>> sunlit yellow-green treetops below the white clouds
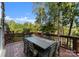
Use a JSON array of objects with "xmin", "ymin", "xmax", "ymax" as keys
[{"xmin": 8, "ymin": 21, "xmax": 40, "ymax": 33}]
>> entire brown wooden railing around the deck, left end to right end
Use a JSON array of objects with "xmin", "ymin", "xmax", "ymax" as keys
[{"xmin": 5, "ymin": 32, "xmax": 79, "ymax": 53}]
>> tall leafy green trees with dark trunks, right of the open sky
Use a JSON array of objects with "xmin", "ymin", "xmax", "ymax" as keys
[{"xmin": 34, "ymin": 2, "xmax": 79, "ymax": 35}]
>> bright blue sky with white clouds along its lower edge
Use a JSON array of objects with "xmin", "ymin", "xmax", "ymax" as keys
[{"xmin": 0, "ymin": 2, "xmax": 35, "ymax": 23}]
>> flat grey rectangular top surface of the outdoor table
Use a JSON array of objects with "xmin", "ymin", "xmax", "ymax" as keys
[{"xmin": 25, "ymin": 36, "xmax": 55, "ymax": 49}]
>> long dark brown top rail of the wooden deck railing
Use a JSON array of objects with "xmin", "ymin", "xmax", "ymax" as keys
[{"xmin": 4, "ymin": 32, "xmax": 79, "ymax": 39}]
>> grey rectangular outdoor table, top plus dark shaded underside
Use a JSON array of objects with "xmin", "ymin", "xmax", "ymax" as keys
[{"xmin": 25, "ymin": 36, "xmax": 56, "ymax": 56}]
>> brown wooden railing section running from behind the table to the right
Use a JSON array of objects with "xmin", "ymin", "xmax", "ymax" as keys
[{"xmin": 34, "ymin": 33, "xmax": 79, "ymax": 53}]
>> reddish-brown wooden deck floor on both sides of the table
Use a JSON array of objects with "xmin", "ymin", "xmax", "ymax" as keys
[{"xmin": 5, "ymin": 41, "xmax": 78, "ymax": 57}]
